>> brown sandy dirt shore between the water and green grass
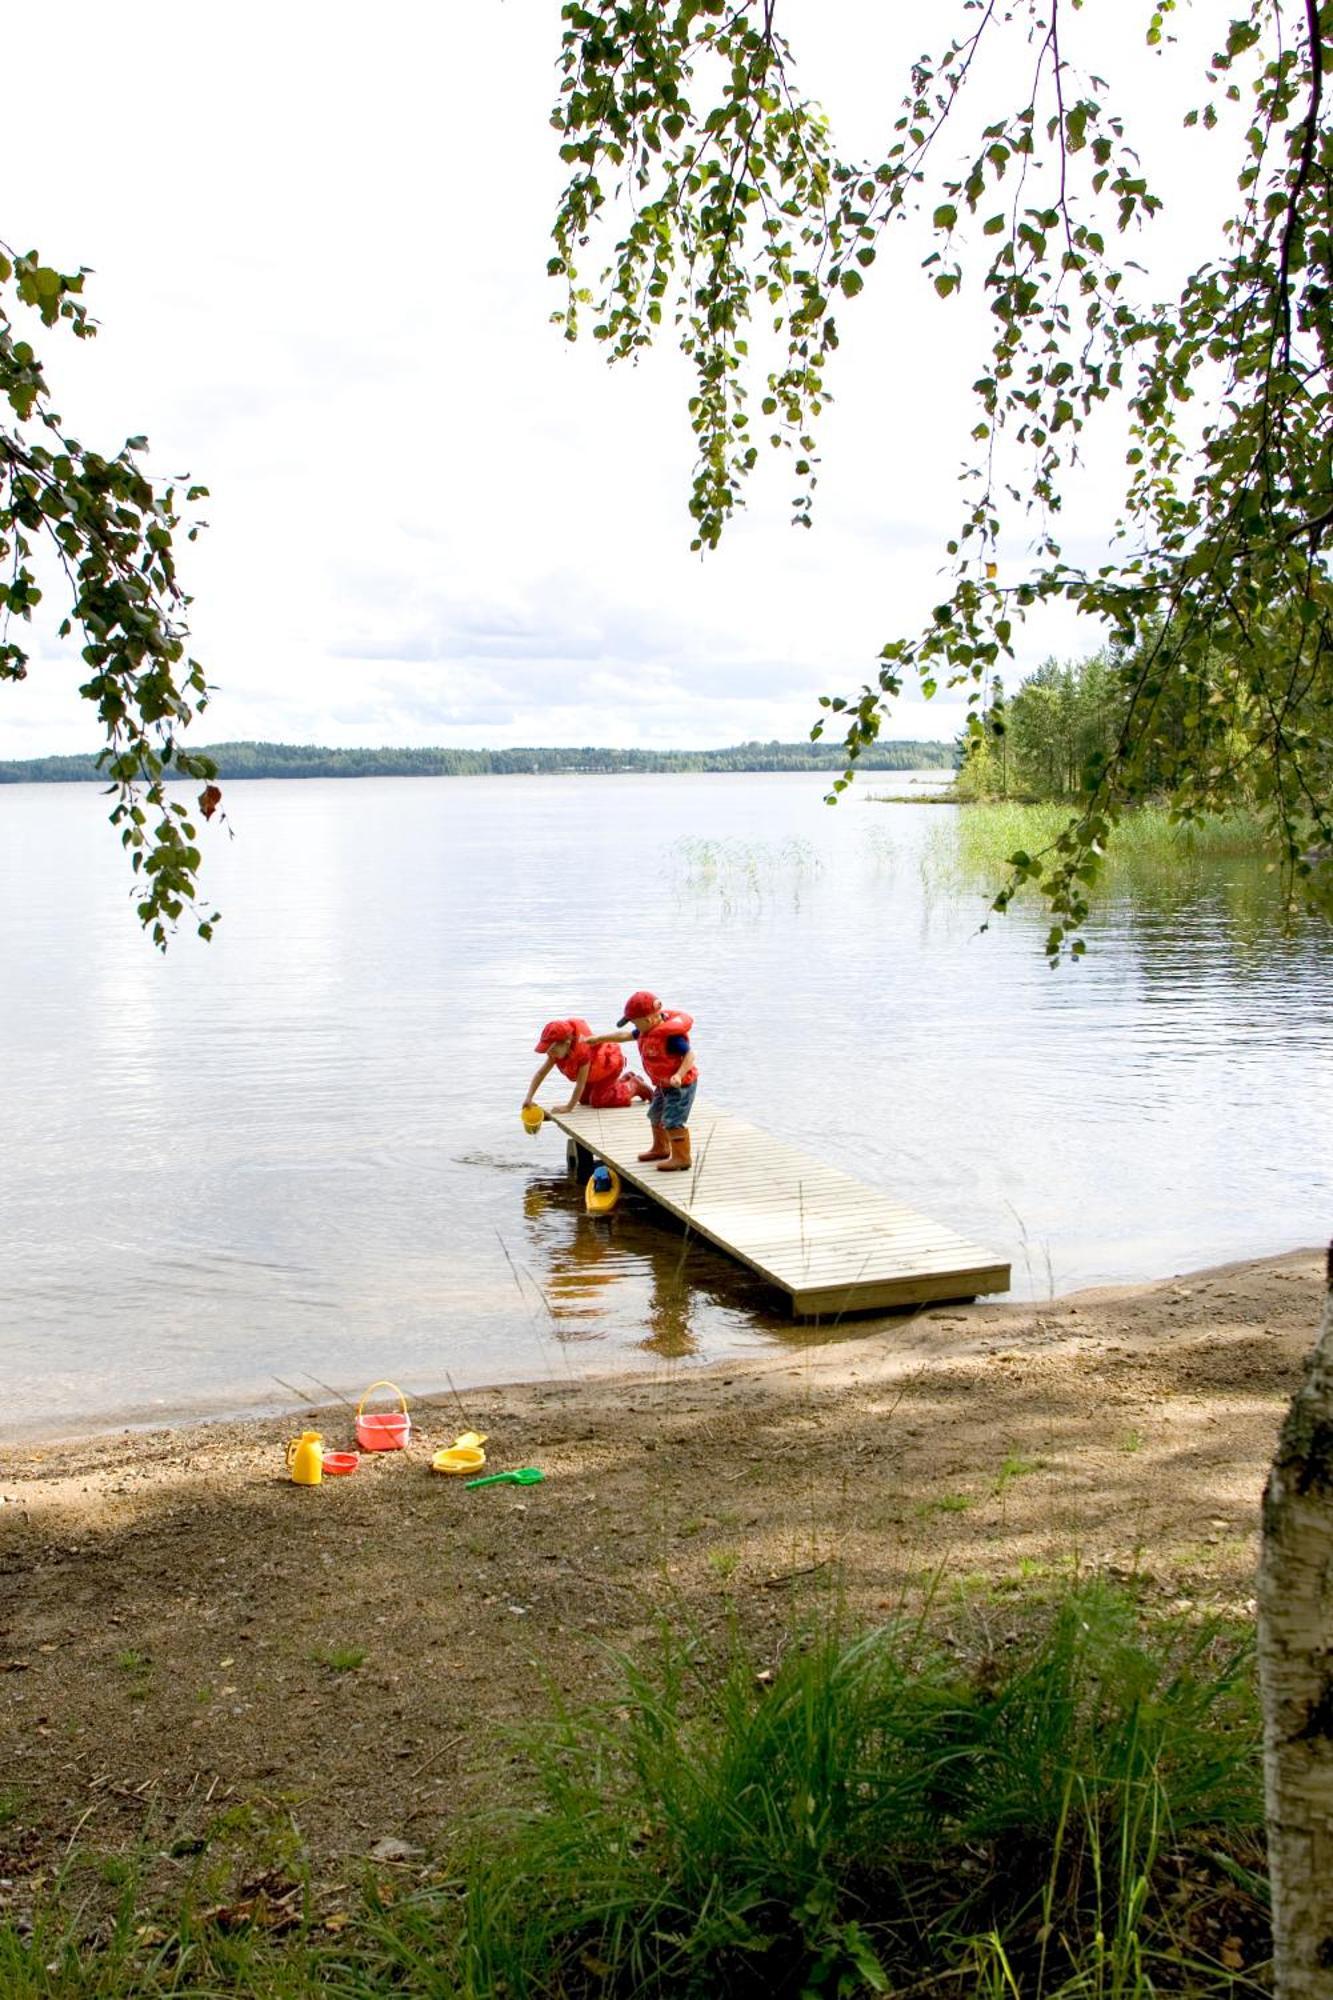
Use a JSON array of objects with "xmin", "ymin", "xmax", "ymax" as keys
[{"xmin": 0, "ymin": 1252, "xmax": 1323, "ymax": 1918}]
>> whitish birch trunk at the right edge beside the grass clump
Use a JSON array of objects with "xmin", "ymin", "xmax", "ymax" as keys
[{"xmin": 1259, "ymin": 1244, "xmax": 1333, "ymax": 2000}]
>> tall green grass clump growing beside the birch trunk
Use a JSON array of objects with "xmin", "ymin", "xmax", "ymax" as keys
[{"xmin": 446, "ymin": 1586, "xmax": 1261, "ymax": 2000}]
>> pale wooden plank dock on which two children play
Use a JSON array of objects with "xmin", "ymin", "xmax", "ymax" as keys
[{"xmin": 548, "ymin": 1102, "xmax": 1009, "ymax": 1318}]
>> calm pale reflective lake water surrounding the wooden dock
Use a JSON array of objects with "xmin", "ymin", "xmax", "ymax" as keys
[{"xmin": 0, "ymin": 774, "xmax": 1333, "ymax": 1436}]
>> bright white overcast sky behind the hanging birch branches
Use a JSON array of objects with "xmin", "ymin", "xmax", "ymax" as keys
[{"xmin": 0, "ymin": 0, "xmax": 1224, "ymax": 756}]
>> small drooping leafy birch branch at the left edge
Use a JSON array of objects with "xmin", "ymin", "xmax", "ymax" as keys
[{"xmin": 0, "ymin": 244, "xmax": 220, "ymax": 946}]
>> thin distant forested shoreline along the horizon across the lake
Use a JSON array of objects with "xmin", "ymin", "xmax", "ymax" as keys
[{"xmin": 0, "ymin": 742, "xmax": 955, "ymax": 784}]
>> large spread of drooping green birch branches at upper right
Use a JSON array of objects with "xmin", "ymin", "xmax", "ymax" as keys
[{"xmin": 550, "ymin": 0, "xmax": 1333, "ymax": 956}]
